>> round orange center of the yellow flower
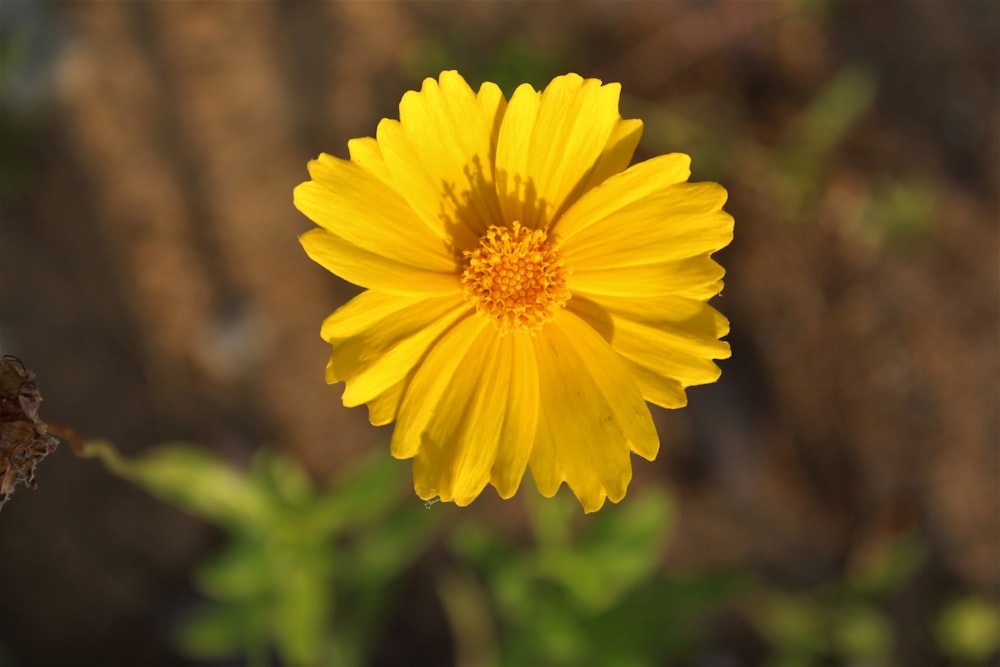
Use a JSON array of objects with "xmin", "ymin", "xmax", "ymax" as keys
[{"xmin": 462, "ymin": 222, "xmax": 569, "ymax": 333}]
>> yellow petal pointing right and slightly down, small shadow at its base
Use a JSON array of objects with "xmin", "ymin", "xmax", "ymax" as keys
[{"xmin": 567, "ymin": 296, "xmax": 730, "ymax": 407}]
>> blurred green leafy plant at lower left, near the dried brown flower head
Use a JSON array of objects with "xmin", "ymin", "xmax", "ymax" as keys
[{"xmin": 87, "ymin": 443, "xmax": 440, "ymax": 665}]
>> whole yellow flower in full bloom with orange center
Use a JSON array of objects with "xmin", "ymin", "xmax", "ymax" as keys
[{"xmin": 295, "ymin": 71, "xmax": 733, "ymax": 512}]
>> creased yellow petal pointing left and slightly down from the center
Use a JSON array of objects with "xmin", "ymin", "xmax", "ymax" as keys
[{"xmin": 321, "ymin": 290, "xmax": 470, "ymax": 408}]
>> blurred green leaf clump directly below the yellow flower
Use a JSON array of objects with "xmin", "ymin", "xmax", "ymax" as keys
[{"xmin": 451, "ymin": 490, "xmax": 739, "ymax": 665}]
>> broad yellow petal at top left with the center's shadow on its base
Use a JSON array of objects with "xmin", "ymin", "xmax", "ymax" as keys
[{"xmin": 377, "ymin": 72, "xmax": 506, "ymax": 250}]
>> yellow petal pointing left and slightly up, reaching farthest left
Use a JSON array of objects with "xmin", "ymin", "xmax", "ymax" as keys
[{"xmin": 294, "ymin": 154, "xmax": 455, "ymax": 272}]
